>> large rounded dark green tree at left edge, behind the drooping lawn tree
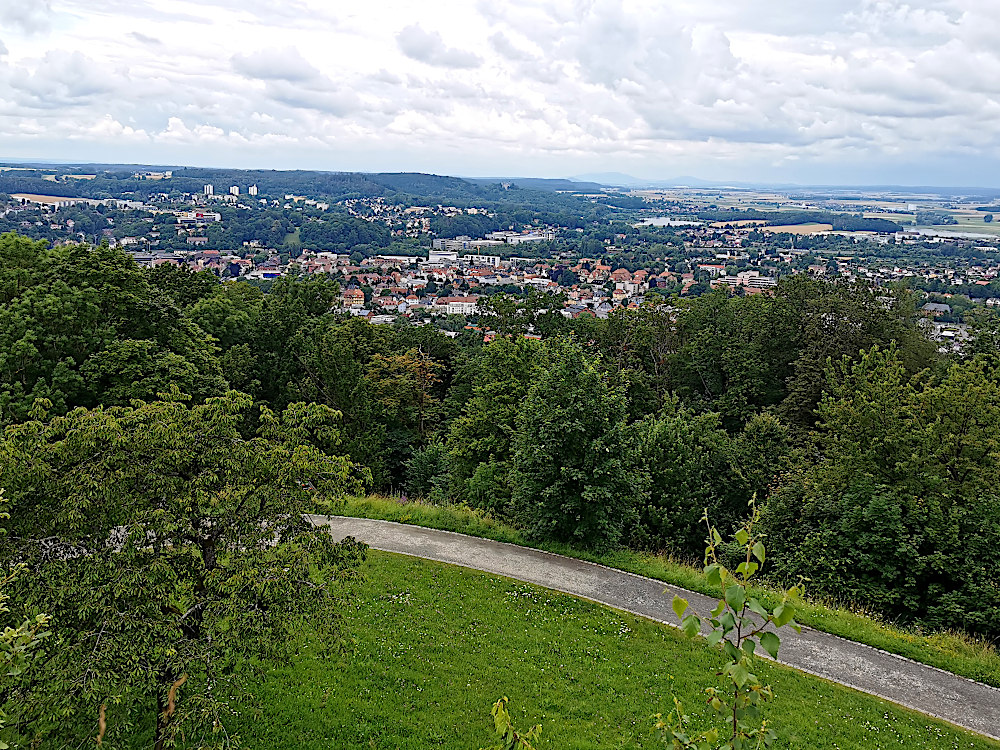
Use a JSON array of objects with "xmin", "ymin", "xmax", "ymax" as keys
[{"xmin": 0, "ymin": 234, "xmax": 226, "ymax": 423}]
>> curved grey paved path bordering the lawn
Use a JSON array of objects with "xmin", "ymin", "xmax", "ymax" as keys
[{"xmin": 310, "ymin": 516, "xmax": 1000, "ymax": 740}]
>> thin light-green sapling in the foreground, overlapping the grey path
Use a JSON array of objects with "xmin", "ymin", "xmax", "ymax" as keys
[{"xmin": 656, "ymin": 503, "xmax": 802, "ymax": 750}]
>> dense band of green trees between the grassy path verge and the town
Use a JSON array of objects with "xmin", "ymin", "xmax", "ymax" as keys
[{"xmin": 0, "ymin": 235, "xmax": 1000, "ymax": 639}]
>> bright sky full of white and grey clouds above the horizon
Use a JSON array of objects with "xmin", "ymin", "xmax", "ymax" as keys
[{"xmin": 0, "ymin": 0, "xmax": 1000, "ymax": 186}]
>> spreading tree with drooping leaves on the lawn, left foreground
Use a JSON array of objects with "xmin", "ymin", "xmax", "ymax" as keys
[{"xmin": 0, "ymin": 392, "xmax": 364, "ymax": 748}]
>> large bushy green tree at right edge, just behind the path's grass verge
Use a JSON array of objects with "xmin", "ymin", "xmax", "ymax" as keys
[{"xmin": 764, "ymin": 349, "xmax": 1000, "ymax": 638}]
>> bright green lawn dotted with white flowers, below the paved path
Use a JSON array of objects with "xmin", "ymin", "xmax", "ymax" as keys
[{"xmin": 244, "ymin": 552, "xmax": 1000, "ymax": 750}]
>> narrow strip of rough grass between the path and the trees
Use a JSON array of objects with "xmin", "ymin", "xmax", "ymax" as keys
[{"xmin": 332, "ymin": 497, "xmax": 1000, "ymax": 687}]
